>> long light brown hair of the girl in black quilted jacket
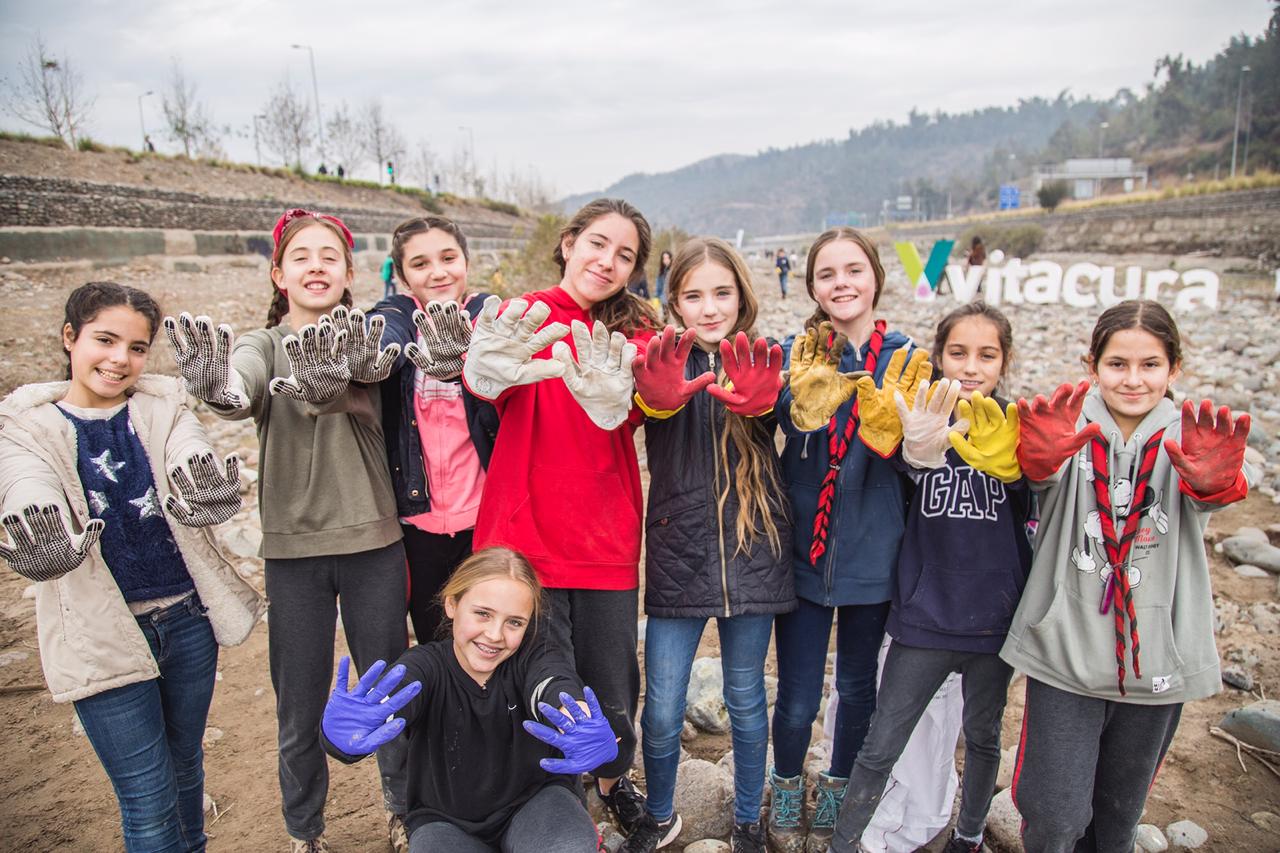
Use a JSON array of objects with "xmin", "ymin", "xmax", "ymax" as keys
[{"xmin": 668, "ymin": 237, "xmax": 782, "ymax": 557}]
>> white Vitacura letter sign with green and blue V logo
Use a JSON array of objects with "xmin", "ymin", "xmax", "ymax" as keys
[{"xmin": 893, "ymin": 240, "xmax": 1219, "ymax": 311}]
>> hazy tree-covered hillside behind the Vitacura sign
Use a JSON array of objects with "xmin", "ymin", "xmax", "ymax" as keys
[{"xmin": 559, "ymin": 5, "xmax": 1280, "ymax": 236}]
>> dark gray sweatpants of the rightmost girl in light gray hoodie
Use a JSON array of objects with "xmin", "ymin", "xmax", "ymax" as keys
[{"xmin": 1014, "ymin": 679, "xmax": 1183, "ymax": 853}]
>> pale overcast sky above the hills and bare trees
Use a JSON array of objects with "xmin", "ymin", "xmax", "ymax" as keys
[{"xmin": 0, "ymin": 0, "xmax": 1271, "ymax": 195}]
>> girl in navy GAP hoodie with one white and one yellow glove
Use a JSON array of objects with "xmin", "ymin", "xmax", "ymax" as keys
[{"xmin": 831, "ymin": 302, "xmax": 1033, "ymax": 853}]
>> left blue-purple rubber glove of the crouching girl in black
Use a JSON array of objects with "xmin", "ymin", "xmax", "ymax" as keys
[{"xmin": 320, "ymin": 657, "xmax": 422, "ymax": 756}]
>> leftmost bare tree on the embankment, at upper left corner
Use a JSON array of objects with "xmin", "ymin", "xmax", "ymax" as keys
[{"xmin": 5, "ymin": 36, "xmax": 97, "ymax": 149}]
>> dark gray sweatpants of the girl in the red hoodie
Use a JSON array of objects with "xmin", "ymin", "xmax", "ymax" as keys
[{"xmin": 541, "ymin": 589, "xmax": 640, "ymax": 779}]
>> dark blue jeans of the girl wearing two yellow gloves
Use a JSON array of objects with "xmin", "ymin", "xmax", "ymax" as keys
[{"xmin": 773, "ymin": 598, "xmax": 890, "ymax": 779}]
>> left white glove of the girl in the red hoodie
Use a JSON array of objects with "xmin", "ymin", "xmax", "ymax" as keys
[{"xmin": 462, "ymin": 296, "xmax": 568, "ymax": 400}]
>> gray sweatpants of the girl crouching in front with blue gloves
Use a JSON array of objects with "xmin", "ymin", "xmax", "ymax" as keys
[{"xmin": 408, "ymin": 785, "xmax": 599, "ymax": 853}]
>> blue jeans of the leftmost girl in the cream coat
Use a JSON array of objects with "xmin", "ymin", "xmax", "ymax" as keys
[{"xmin": 76, "ymin": 596, "xmax": 218, "ymax": 853}]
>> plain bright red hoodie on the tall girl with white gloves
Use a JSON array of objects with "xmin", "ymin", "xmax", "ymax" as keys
[{"xmin": 472, "ymin": 287, "xmax": 653, "ymax": 589}]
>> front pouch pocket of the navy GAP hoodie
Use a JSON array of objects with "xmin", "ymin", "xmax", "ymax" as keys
[{"xmin": 899, "ymin": 562, "xmax": 1020, "ymax": 637}]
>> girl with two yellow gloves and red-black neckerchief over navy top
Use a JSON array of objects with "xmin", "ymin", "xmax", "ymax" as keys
[{"xmin": 768, "ymin": 228, "xmax": 929, "ymax": 853}]
